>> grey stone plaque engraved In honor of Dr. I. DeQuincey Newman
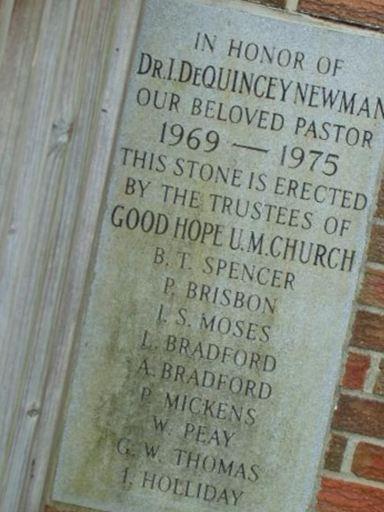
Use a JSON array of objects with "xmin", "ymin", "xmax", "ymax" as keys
[{"xmin": 53, "ymin": 0, "xmax": 384, "ymax": 512}]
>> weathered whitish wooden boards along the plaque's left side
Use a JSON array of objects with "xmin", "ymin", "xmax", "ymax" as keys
[{"xmin": 0, "ymin": 0, "xmax": 140, "ymax": 512}]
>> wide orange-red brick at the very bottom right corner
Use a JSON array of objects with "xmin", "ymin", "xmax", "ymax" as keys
[{"xmin": 317, "ymin": 478, "xmax": 384, "ymax": 512}]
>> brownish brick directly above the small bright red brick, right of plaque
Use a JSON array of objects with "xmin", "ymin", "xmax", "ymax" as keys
[{"xmin": 351, "ymin": 311, "xmax": 384, "ymax": 352}]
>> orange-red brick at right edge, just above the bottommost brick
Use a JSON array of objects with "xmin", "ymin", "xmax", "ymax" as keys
[{"xmin": 352, "ymin": 443, "xmax": 384, "ymax": 482}]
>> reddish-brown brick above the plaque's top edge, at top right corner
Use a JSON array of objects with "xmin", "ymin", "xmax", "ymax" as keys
[{"xmin": 299, "ymin": 0, "xmax": 384, "ymax": 30}]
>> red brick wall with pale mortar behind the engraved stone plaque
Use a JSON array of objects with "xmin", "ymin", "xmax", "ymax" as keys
[{"xmin": 252, "ymin": 0, "xmax": 384, "ymax": 512}]
